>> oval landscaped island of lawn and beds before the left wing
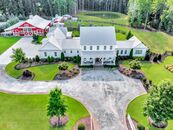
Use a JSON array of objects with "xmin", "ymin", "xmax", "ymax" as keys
[{"xmin": 5, "ymin": 62, "xmax": 80, "ymax": 81}]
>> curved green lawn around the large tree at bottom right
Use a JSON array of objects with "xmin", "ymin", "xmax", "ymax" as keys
[{"xmin": 127, "ymin": 95, "xmax": 173, "ymax": 130}]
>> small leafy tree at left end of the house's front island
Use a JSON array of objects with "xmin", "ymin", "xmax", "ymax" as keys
[{"xmin": 11, "ymin": 48, "xmax": 25, "ymax": 63}]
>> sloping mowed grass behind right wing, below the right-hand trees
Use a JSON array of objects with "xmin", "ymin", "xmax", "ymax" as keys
[{"xmin": 132, "ymin": 29, "xmax": 173, "ymax": 54}]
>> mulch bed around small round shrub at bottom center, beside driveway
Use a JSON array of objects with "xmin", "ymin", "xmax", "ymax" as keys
[{"xmin": 72, "ymin": 117, "xmax": 91, "ymax": 130}]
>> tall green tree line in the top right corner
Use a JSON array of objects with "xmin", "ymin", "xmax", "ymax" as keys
[{"xmin": 128, "ymin": 0, "xmax": 173, "ymax": 33}]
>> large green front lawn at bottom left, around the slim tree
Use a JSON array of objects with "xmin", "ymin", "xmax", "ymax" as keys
[{"xmin": 0, "ymin": 93, "xmax": 89, "ymax": 130}]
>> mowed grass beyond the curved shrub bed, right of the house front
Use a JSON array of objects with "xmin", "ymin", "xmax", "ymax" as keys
[{"xmin": 122, "ymin": 56, "xmax": 173, "ymax": 84}]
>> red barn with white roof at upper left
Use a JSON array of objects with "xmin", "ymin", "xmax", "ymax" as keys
[{"xmin": 5, "ymin": 15, "xmax": 51, "ymax": 36}]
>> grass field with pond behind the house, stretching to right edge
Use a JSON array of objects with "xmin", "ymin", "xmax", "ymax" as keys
[{"xmin": 72, "ymin": 11, "xmax": 173, "ymax": 54}]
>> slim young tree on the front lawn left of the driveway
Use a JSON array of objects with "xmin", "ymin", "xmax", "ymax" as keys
[{"xmin": 47, "ymin": 88, "xmax": 67, "ymax": 126}]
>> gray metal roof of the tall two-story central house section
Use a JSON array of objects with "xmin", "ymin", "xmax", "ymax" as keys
[{"xmin": 80, "ymin": 27, "xmax": 116, "ymax": 45}]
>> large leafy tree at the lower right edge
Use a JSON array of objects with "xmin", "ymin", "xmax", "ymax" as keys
[{"xmin": 144, "ymin": 80, "xmax": 173, "ymax": 127}]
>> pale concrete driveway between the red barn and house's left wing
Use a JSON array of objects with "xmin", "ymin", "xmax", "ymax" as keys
[{"xmin": 0, "ymin": 37, "xmax": 41, "ymax": 65}]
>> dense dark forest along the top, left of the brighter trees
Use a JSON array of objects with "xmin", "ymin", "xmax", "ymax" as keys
[{"xmin": 0, "ymin": 0, "xmax": 128, "ymax": 17}]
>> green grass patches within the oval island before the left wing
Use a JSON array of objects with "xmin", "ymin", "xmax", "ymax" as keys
[{"xmin": 5, "ymin": 62, "xmax": 74, "ymax": 81}]
